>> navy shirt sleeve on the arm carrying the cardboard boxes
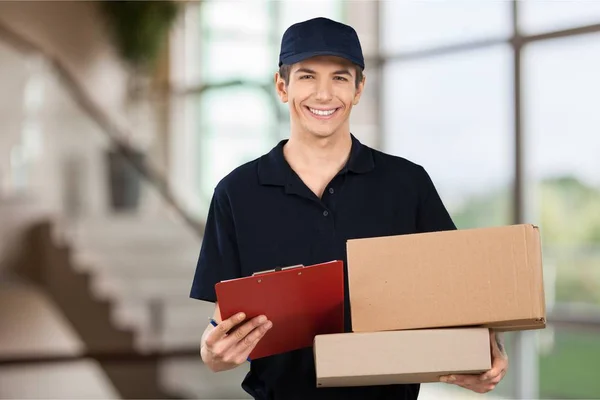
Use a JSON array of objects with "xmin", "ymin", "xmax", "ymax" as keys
[{"xmin": 417, "ymin": 167, "xmax": 456, "ymax": 233}]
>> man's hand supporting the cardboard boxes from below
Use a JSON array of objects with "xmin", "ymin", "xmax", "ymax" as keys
[{"xmin": 440, "ymin": 330, "xmax": 508, "ymax": 393}]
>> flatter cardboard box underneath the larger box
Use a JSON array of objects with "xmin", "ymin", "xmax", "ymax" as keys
[{"xmin": 313, "ymin": 328, "xmax": 491, "ymax": 387}]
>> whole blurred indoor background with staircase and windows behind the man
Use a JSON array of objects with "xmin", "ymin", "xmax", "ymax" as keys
[{"xmin": 0, "ymin": 0, "xmax": 600, "ymax": 399}]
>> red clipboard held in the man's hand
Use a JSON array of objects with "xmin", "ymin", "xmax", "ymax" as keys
[{"xmin": 215, "ymin": 261, "xmax": 344, "ymax": 360}]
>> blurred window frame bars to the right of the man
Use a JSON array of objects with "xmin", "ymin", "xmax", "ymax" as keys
[{"xmin": 378, "ymin": 1, "xmax": 600, "ymax": 398}]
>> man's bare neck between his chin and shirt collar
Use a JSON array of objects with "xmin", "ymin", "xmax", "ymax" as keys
[{"xmin": 283, "ymin": 132, "xmax": 352, "ymax": 173}]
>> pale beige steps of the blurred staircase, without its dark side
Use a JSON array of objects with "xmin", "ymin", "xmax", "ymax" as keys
[{"xmin": 71, "ymin": 215, "xmax": 204, "ymax": 351}]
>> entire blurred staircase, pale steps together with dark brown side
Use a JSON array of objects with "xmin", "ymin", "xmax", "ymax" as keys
[{"xmin": 14, "ymin": 214, "xmax": 249, "ymax": 399}]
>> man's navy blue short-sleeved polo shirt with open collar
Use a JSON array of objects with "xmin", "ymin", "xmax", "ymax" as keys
[{"xmin": 191, "ymin": 136, "xmax": 456, "ymax": 400}]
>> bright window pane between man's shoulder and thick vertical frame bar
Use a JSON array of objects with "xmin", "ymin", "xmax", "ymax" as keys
[{"xmin": 382, "ymin": 46, "xmax": 513, "ymax": 228}]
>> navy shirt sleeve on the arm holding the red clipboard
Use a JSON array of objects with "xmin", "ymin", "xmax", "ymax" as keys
[{"xmin": 190, "ymin": 187, "xmax": 241, "ymax": 302}]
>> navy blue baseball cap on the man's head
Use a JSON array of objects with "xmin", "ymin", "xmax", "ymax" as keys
[{"xmin": 279, "ymin": 17, "xmax": 365, "ymax": 69}]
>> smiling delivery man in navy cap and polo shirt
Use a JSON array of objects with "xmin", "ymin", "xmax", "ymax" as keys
[{"xmin": 191, "ymin": 18, "xmax": 507, "ymax": 400}]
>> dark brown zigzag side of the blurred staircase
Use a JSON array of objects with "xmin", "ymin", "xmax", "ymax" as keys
[{"xmin": 18, "ymin": 222, "xmax": 172, "ymax": 399}]
